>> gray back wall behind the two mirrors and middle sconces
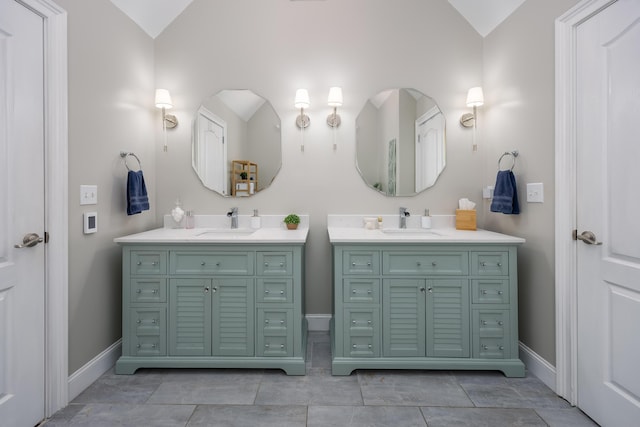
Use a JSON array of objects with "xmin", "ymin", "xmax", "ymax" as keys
[{"xmin": 155, "ymin": 0, "xmax": 482, "ymax": 320}]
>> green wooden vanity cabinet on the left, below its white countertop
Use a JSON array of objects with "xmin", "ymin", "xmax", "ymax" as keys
[{"xmin": 116, "ymin": 243, "xmax": 307, "ymax": 375}]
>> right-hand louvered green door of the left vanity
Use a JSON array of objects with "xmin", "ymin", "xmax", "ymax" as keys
[{"xmin": 211, "ymin": 278, "xmax": 255, "ymax": 356}]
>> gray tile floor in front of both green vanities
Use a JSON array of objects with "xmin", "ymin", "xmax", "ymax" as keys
[{"xmin": 44, "ymin": 332, "xmax": 596, "ymax": 427}]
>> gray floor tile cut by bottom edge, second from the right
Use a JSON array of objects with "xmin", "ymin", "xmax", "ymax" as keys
[{"xmin": 421, "ymin": 408, "xmax": 546, "ymax": 427}]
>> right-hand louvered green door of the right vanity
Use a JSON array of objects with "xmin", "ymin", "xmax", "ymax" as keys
[{"xmin": 426, "ymin": 279, "xmax": 470, "ymax": 357}]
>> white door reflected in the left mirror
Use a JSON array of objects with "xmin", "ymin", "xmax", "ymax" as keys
[{"xmin": 193, "ymin": 107, "xmax": 229, "ymax": 195}]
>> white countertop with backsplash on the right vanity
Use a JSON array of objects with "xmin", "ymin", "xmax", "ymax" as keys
[{"xmin": 327, "ymin": 215, "xmax": 525, "ymax": 244}]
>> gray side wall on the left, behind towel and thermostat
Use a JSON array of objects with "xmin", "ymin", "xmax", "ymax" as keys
[{"xmin": 58, "ymin": 0, "xmax": 160, "ymax": 373}]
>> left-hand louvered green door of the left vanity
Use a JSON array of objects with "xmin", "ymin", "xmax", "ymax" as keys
[{"xmin": 169, "ymin": 279, "xmax": 212, "ymax": 356}]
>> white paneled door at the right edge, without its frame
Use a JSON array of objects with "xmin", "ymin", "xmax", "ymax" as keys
[{"xmin": 576, "ymin": 0, "xmax": 640, "ymax": 426}]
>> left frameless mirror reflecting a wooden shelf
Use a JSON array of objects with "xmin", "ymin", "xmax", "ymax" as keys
[{"xmin": 191, "ymin": 89, "xmax": 282, "ymax": 197}]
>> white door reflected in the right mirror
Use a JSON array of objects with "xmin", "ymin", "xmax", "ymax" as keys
[{"xmin": 416, "ymin": 107, "xmax": 445, "ymax": 193}]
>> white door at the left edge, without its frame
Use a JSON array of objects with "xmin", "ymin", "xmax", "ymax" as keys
[{"xmin": 0, "ymin": 0, "xmax": 45, "ymax": 427}]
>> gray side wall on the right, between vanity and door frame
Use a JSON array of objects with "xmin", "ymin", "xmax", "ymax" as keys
[{"xmin": 478, "ymin": 0, "xmax": 577, "ymax": 364}]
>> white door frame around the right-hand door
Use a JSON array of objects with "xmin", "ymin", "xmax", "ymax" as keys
[{"xmin": 555, "ymin": 0, "xmax": 617, "ymax": 405}]
